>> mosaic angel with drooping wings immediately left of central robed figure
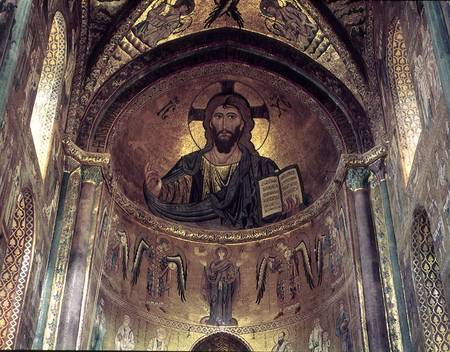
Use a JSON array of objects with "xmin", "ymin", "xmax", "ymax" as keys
[{"xmin": 131, "ymin": 239, "xmax": 187, "ymax": 312}]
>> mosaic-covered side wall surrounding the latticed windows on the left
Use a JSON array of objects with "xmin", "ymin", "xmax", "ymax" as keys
[{"xmin": 0, "ymin": 1, "xmax": 79, "ymax": 348}]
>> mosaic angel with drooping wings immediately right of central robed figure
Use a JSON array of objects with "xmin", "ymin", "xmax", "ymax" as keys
[{"xmin": 256, "ymin": 240, "xmax": 314, "ymax": 319}]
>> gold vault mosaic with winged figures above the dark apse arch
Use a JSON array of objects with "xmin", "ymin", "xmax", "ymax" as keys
[{"xmin": 87, "ymin": 0, "xmax": 363, "ymax": 102}]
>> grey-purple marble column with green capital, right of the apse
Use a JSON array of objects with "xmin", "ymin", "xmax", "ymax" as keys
[{"xmin": 346, "ymin": 167, "xmax": 389, "ymax": 352}]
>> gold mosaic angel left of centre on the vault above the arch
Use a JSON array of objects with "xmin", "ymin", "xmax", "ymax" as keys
[{"xmin": 132, "ymin": 0, "xmax": 195, "ymax": 48}]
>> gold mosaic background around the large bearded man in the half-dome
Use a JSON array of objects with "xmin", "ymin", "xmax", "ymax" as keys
[{"xmin": 109, "ymin": 63, "xmax": 342, "ymax": 226}]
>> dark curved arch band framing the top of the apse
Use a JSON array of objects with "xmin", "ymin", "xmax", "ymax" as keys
[{"xmin": 77, "ymin": 28, "xmax": 374, "ymax": 153}]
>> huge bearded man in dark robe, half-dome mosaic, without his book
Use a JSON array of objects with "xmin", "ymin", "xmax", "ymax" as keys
[{"xmin": 144, "ymin": 92, "xmax": 301, "ymax": 228}]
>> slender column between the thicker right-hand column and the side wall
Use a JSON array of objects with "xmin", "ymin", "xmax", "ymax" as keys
[{"xmin": 369, "ymin": 159, "xmax": 412, "ymax": 351}]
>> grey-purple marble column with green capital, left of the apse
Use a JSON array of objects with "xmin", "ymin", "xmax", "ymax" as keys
[{"xmin": 56, "ymin": 166, "xmax": 103, "ymax": 350}]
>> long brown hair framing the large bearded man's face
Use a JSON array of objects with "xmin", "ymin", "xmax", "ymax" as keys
[{"xmin": 203, "ymin": 93, "xmax": 258, "ymax": 154}]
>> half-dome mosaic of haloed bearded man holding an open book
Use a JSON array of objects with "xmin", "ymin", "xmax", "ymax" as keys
[{"xmin": 107, "ymin": 64, "xmax": 342, "ymax": 229}]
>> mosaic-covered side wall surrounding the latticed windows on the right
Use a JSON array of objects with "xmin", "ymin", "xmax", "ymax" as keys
[{"xmin": 374, "ymin": 1, "xmax": 450, "ymax": 351}]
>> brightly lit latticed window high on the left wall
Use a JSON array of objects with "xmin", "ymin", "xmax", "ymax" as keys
[{"xmin": 30, "ymin": 12, "xmax": 67, "ymax": 179}]
